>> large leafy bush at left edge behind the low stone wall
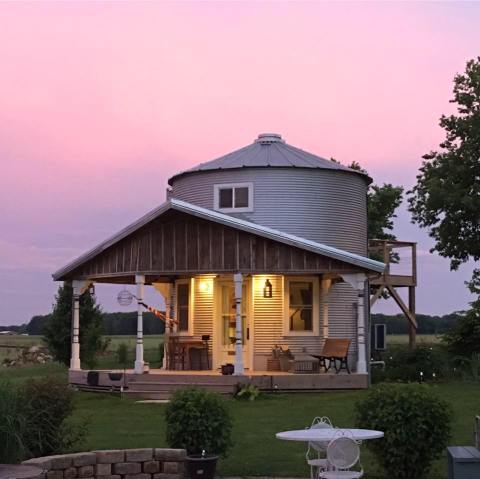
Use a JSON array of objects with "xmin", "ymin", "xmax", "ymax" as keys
[{"xmin": 0, "ymin": 378, "xmax": 84, "ymax": 463}]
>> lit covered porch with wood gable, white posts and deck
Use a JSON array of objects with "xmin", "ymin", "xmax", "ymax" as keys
[{"xmin": 54, "ymin": 200, "xmax": 383, "ymax": 396}]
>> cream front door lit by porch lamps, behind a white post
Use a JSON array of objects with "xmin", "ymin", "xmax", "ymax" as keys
[{"xmin": 215, "ymin": 280, "xmax": 251, "ymax": 369}]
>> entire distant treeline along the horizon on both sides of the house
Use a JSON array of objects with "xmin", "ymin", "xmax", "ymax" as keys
[{"xmin": 0, "ymin": 312, "xmax": 462, "ymax": 335}]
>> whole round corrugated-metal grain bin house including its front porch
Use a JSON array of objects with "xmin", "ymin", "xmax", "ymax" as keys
[{"xmin": 54, "ymin": 133, "xmax": 384, "ymax": 397}]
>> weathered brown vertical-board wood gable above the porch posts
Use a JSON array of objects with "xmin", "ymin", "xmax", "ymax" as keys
[{"xmin": 59, "ymin": 211, "xmax": 366, "ymax": 280}]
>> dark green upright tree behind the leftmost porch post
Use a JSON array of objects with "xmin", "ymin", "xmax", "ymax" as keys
[{"xmin": 44, "ymin": 284, "xmax": 108, "ymax": 367}]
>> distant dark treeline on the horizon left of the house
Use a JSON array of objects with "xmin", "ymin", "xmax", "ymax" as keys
[{"xmin": 0, "ymin": 312, "xmax": 165, "ymax": 335}]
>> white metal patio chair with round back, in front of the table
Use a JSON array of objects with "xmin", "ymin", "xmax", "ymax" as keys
[{"xmin": 319, "ymin": 436, "xmax": 363, "ymax": 479}]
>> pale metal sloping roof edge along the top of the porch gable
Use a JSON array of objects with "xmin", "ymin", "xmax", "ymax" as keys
[{"xmin": 52, "ymin": 198, "xmax": 385, "ymax": 281}]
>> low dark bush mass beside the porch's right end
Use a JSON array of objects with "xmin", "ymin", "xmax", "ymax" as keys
[{"xmin": 372, "ymin": 345, "xmax": 451, "ymax": 383}]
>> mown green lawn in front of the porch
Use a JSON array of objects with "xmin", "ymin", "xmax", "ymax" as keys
[{"xmin": 0, "ymin": 364, "xmax": 480, "ymax": 479}]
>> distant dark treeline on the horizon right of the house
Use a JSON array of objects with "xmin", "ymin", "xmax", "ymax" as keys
[{"xmin": 372, "ymin": 312, "xmax": 462, "ymax": 334}]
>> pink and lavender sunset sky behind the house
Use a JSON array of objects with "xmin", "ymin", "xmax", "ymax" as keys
[{"xmin": 0, "ymin": 2, "xmax": 480, "ymax": 324}]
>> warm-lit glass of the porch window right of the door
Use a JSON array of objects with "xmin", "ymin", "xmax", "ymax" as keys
[{"xmin": 289, "ymin": 281, "xmax": 313, "ymax": 331}]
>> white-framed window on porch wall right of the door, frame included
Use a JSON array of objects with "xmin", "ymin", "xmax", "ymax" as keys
[{"xmin": 284, "ymin": 276, "xmax": 320, "ymax": 336}]
